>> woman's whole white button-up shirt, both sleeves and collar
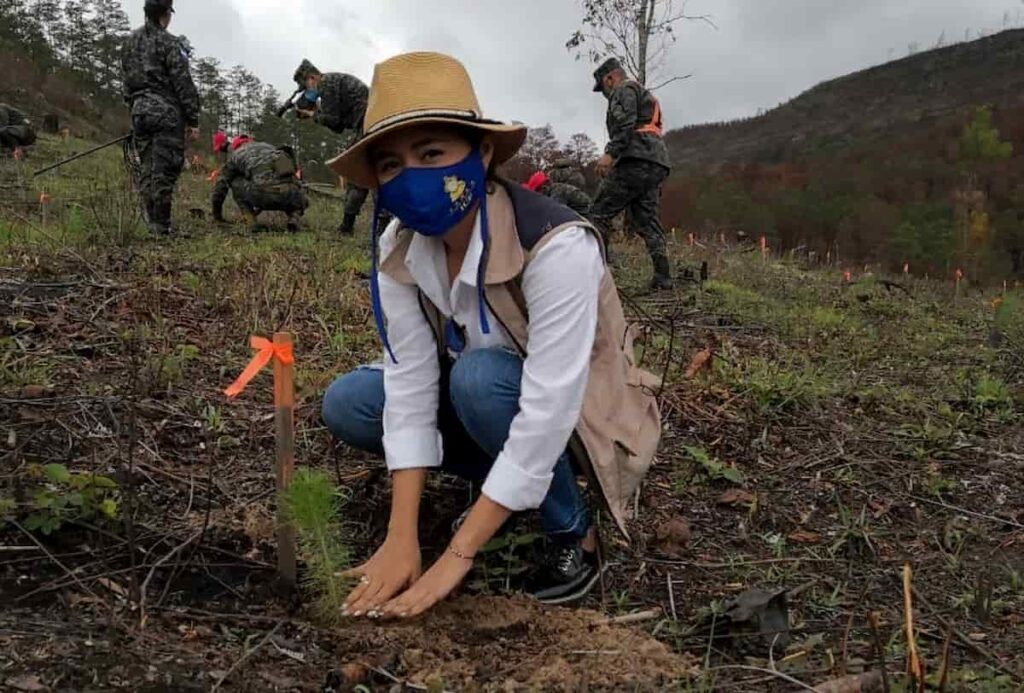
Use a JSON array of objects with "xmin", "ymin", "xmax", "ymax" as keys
[{"xmin": 380, "ymin": 216, "xmax": 604, "ymax": 511}]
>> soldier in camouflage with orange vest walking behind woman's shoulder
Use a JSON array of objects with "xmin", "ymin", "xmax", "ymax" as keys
[{"xmin": 591, "ymin": 57, "xmax": 672, "ymax": 289}]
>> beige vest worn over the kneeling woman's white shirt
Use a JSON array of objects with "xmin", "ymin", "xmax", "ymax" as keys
[{"xmin": 380, "ymin": 185, "xmax": 662, "ymax": 537}]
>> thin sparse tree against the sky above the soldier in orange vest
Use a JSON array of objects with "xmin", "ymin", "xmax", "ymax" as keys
[{"xmin": 565, "ymin": 0, "xmax": 715, "ymax": 89}]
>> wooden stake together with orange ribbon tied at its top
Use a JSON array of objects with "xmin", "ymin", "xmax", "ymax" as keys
[{"xmin": 224, "ymin": 332, "xmax": 296, "ymax": 588}]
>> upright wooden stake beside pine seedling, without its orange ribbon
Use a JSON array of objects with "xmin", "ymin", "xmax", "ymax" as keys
[{"xmin": 273, "ymin": 332, "xmax": 296, "ymax": 588}]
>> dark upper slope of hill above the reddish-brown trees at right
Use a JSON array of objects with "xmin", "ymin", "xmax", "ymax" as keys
[{"xmin": 667, "ymin": 30, "xmax": 1024, "ymax": 170}]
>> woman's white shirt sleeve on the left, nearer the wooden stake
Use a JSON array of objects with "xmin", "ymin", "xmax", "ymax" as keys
[{"xmin": 379, "ymin": 233, "xmax": 442, "ymax": 471}]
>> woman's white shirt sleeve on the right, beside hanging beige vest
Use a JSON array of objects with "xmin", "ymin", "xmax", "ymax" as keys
[{"xmin": 482, "ymin": 228, "xmax": 604, "ymax": 512}]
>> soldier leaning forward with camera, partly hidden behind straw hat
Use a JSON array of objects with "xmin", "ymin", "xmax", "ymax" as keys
[{"xmin": 294, "ymin": 60, "xmax": 370, "ymax": 235}]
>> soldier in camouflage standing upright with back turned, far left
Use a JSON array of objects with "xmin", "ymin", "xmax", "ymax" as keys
[{"xmin": 121, "ymin": 0, "xmax": 200, "ymax": 234}]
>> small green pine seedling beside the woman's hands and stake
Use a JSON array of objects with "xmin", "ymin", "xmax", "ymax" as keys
[{"xmin": 281, "ymin": 468, "xmax": 351, "ymax": 623}]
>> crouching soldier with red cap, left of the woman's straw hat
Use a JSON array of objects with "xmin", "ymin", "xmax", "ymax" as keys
[{"xmin": 213, "ymin": 138, "xmax": 308, "ymax": 231}]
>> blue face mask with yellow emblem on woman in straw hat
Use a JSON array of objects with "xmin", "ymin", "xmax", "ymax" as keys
[{"xmin": 378, "ymin": 149, "xmax": 487, "ymax": 236}]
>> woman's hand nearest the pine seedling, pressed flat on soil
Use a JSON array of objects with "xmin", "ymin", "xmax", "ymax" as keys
[{"xmin": 341, "ymin": 533, "xmax": 423, "ymax": 617}]
